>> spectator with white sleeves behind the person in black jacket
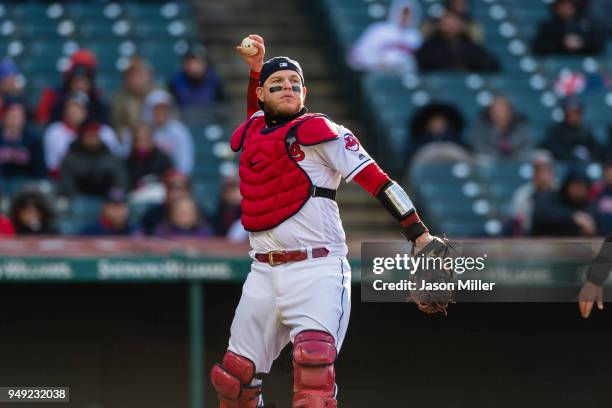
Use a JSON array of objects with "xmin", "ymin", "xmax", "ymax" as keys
[{"xmin": 43, "ymin": 91, "xmax": 131, "ymax": 176}]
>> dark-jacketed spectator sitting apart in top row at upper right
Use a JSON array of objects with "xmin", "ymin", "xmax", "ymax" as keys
[{"xmin": 532, "ymin": 0, "xmax": 604, "ymax": 55}]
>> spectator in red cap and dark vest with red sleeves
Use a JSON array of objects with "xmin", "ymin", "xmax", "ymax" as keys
[{"xmin": 36, "ymin": 49, "xmax": 109, "ymax": 124}]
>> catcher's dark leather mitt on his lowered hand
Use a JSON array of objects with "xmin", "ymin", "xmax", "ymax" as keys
[{"xmin": 410, "ymin": 237, "xmax": 454, "ymax": 315}]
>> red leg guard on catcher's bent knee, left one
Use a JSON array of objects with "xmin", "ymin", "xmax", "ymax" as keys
[{"xmin": 210, "ymin": 351, "xmax": 261, "ymax": 408}]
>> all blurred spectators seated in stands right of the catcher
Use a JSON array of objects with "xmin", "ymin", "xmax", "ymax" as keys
[{"xmin": 347, "ymin": 0, "xmax": 612, "ymax": 236}]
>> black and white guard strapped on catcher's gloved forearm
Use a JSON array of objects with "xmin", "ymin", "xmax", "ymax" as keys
[{"xmin": 376, "ymin": 180, "xmax": 428, "ymax": 241}]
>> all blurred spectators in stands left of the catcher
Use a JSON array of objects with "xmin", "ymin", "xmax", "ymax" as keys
[{"xmin": 0, "ymin": 41, "xmax": 246, "ymax": 241}]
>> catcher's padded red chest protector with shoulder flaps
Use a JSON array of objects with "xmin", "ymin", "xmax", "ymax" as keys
[{"xmin": 230, "ymin": 114, "xmax": 338, "ymax": 232}]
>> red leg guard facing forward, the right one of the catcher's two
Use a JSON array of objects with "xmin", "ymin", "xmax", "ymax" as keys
[{"xmin": 292, "ymin": 330, "xmax": 337, "ymax": 408}]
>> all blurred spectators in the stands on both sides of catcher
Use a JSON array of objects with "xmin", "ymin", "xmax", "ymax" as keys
[{"xmin": 0, "ymin": 0, "xmax": 612, "ymax": 241}]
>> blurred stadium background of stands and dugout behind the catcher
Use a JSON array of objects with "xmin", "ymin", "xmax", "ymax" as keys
[{"xmin": 0, "ymin": 0, "xmax": 612, "ymax": 408}]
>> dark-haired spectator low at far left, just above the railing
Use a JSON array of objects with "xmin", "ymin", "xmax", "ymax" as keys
[{"xmin": 10, "ymin": 189, "xmax": 58, "ymax": 235}]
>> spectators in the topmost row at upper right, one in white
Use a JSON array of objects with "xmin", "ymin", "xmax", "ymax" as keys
[{"xmin": 347, "ymin": 0, "xmax": 612, "ymax": 74}]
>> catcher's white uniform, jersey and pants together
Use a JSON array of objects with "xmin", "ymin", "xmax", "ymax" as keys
[{"xmin": 228, "ymin": 113, "xmax": 366, "ymax": 380}]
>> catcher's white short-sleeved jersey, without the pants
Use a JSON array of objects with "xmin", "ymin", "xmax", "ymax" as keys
[{"xmin": 250, "ymin": 113, "xmax": 373, "ymax": 256}]
